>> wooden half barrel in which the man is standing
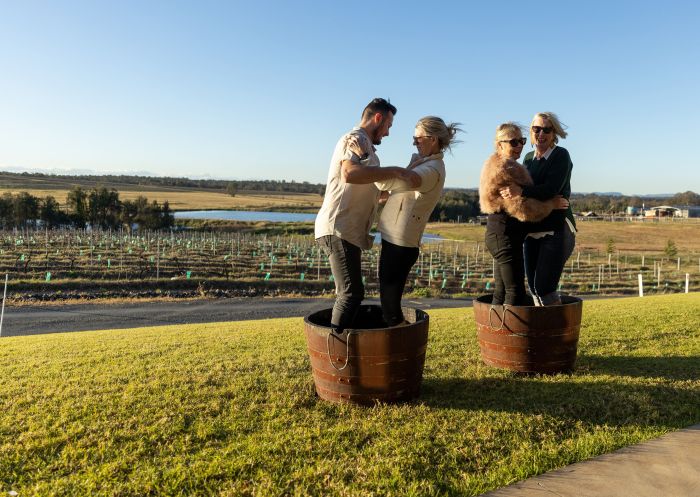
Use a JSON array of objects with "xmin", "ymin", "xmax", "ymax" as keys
[{"xmin": 304, "ymin": 305, "xmax": 428, "ymax": 405}]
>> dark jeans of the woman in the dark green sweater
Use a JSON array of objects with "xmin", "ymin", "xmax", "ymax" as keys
[{"xmin": 524, "ymin": 230, "xmax": 576, "ymax": 305}]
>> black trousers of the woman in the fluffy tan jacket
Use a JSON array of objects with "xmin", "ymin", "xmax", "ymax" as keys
[{"xmin": 486, "ymin": 232, "xmax": 526, "ymax": 305}]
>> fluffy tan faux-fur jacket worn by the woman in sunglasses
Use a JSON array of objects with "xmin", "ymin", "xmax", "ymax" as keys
[{"xmin": 479, "ymin": 154, "xmax": 555, "ymax": 222}]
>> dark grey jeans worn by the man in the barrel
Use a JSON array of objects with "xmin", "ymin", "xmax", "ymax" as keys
[{"xmin": 316, "ymin": 235, "xmax": 365, "ymax": 332}]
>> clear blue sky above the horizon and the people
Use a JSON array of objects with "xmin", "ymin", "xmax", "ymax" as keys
[{"xmin": 0, "ymin": 0, "xmax": 700, "ymax": 194}]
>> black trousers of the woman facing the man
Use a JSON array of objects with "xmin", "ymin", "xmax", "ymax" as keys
[{"xmin": 379, "ymin": 240, "xmax": 419, "ymax": 326}]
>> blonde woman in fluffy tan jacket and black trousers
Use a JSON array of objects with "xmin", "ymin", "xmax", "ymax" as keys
[{"xmin": 479, "ymin": 122, "xmax": 569, "ymax": 305}]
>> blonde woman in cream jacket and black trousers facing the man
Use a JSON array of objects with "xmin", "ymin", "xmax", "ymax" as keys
[{"xmin": 375, "ymin": 116, "xmax": 461, "ymax": 326}]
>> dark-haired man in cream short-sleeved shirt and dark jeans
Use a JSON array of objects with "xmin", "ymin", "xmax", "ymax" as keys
[{"xmin": 315, "ymin": 98, "xmax": 420, "ymax": 333}]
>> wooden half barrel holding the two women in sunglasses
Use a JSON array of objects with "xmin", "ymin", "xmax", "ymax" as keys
[{"xmin": 474, "ymin": 295, "xmax": 583, "ymax": 374}]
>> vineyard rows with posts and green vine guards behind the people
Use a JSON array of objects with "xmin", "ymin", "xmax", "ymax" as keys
[{"xmin": 0, "ymin": 229, "xmax": 700, "ymax": 301}]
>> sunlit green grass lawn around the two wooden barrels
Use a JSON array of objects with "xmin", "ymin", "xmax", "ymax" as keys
[{"xmin": 0, "ymin": 294, "xmax": 700, "ymax": 496}]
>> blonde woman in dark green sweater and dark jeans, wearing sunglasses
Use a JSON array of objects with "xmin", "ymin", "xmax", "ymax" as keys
[{"xmin": 501, "ymin": 112, "xmax": 576, "ymax": 305}]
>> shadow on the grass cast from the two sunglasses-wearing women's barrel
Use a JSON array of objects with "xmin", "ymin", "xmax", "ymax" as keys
[{"xmin": 576, "ymin": 354, "xmax": 700, "ymax": 381}]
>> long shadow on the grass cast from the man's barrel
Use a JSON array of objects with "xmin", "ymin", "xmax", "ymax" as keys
[{"xmin": 419, "ymin": 368, "xmax": 700, "ymax": 428}]
